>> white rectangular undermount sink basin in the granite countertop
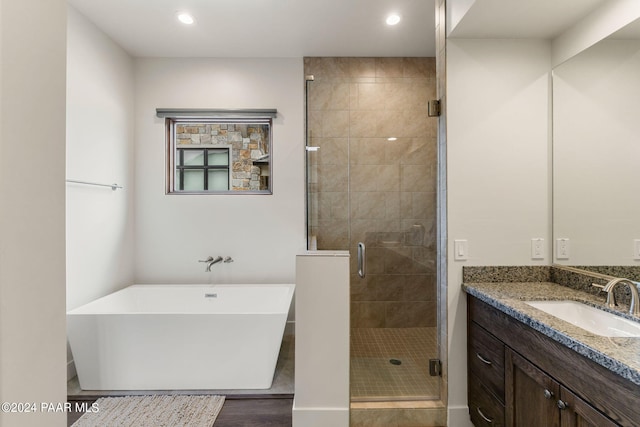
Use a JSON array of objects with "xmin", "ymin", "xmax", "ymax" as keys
[{"xmin": 525, "ymin": 301, "xmax": 640, "ymax": 337}]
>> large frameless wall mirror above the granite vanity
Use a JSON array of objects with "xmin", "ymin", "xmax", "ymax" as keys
[{"xmin": 553, "ymin": 20, "xmax": 640, "ymax": 266}]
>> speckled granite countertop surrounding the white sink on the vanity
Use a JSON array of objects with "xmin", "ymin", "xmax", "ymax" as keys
[{"xmin": 462, "ymin": 282, "xmax": 640, "ymax": 386}]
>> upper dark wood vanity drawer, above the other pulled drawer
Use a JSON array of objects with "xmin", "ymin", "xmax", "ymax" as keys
[{"xmin": 468, "ymin": 322, "xmax": 504, "ymax": 403}]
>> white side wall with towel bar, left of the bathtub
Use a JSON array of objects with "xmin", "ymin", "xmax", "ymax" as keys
[{"xmin": 66, "ymin": 6, "xmax": 134, "ymax": 377}]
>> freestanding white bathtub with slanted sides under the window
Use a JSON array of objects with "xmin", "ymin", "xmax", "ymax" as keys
[{"xmin": 67, "ymin": 284, "xmax": 295, "ymax": 390}]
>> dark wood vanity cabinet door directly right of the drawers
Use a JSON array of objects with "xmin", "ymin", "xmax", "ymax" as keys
[{"xmin": 505, "ymin": 348, "xmax": 560, "ymax": 427}]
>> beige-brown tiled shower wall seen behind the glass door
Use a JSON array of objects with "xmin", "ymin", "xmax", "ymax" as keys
[{"xmin": 305, "ymin": 57, "xmax": 437, "ymax": 328}]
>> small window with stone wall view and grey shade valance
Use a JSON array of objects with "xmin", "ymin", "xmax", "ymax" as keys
[{"xmin": 157, "ymin": 109, "xmax": 276, "ymax": 194}]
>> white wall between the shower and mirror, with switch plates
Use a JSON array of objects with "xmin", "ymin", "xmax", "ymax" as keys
[{"xmin": 447, "ymin": 39, "xmax": 551, "ymax": 426}]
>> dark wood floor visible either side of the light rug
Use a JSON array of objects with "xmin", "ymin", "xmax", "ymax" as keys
[{"xmin": 67, "ymin": 396, "xmax": 293, "ymax": 427}]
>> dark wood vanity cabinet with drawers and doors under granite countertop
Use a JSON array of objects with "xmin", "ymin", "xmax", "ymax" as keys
[{"xmin": 467, "ymin": 295, "xmax": 640, "ymax": 427}]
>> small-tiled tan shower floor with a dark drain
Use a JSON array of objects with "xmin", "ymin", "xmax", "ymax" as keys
[{"xmin": 351, "ymin": 328, "xmax": 440, "ymax": 401}]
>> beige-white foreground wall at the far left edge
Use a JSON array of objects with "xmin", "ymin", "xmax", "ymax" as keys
[{"xmin": 0, "ymin": 0, "xmax": 66, "ymax": 427}]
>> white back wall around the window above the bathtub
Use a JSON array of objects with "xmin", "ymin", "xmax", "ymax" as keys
[{"xmin": 135, "ymin": 58, "xmax": 305, "ymax": 283}]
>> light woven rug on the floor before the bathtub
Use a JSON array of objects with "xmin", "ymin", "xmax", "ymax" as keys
[{"xmin": 72, "ymin": 395, "xmax": 224, "ymax": 427}]
